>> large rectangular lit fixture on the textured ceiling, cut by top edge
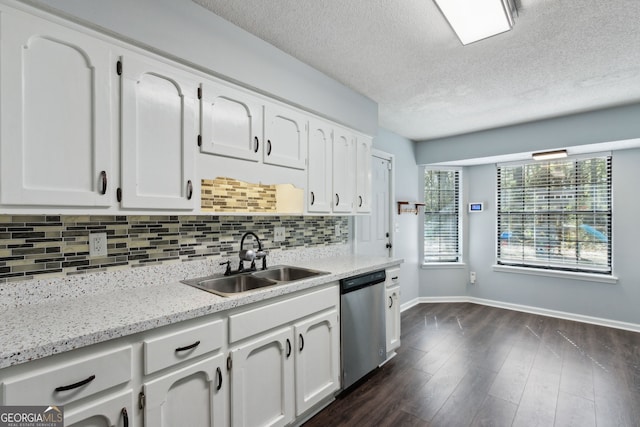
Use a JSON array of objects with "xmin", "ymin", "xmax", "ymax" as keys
[{"xmin": 433, "ymin": 0, "xmax": 516, "ymax": 45}]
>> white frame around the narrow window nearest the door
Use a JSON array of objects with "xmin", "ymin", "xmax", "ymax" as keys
[{"xmin": 420, "ymin": 165, "xmax": 465, "ymax": 267}]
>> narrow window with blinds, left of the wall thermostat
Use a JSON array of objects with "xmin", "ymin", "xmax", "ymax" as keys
[{"xmin": 424, "ymin": 169, "xmax": 462, "ymax": 263}]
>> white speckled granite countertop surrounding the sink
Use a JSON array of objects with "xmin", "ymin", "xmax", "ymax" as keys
[{"xmin": 0, "ymin": 256, "xmax": 402, "ymax": 368}]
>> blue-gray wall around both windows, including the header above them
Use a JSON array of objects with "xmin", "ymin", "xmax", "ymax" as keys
[{"xmin": 416, "ymin": 105, "xmax": 640, "ymax": 324}]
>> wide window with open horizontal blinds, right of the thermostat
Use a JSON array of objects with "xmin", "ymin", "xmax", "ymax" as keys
[{"xmin": 497, "ymin": 155, "xmax": 611, "ymax": 274}]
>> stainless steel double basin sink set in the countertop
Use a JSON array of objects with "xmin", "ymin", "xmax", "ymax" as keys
[{"xmin": 182, "ymin": 265, "xmax": 329, "ymax": 297}]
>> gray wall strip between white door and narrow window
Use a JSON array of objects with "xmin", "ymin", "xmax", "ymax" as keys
[{"xmin": 373, "ymin": 129, "xmax": 421, "ymax": 303}]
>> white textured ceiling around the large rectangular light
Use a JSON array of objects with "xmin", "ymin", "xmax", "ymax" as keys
[{"xmin": 194, "ymin": 0, "xmax": 640, "ymax": 140}]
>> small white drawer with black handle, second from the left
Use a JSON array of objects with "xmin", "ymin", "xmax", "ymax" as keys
[{"xmin": 144, "ymin": 320, "xmax": 225, "ymax": 374}]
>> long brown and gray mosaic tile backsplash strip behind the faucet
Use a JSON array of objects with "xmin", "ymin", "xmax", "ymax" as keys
[{"xmin": 0, "ymin": 215, "xmax": 349, "ymax": 283}]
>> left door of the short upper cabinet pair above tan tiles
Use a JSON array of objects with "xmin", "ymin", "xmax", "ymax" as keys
[{"xmin": 200, "ymin": 81, "xmax": 263, "ymax": 162}]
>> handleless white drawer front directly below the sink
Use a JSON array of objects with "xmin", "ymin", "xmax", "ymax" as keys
[{"xmin": 229, "ymin": 285, "xmax": 340, "ymax": 342}]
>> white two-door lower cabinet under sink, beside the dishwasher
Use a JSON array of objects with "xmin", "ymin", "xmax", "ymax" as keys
[{"xmin": 229, "ymin": 284, "xmax": 340, "ymax": 427}]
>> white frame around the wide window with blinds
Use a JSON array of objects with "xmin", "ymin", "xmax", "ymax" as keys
[{"xmin": 494, "ymin": 152, "xmax": 615, "ymax": 281}]
